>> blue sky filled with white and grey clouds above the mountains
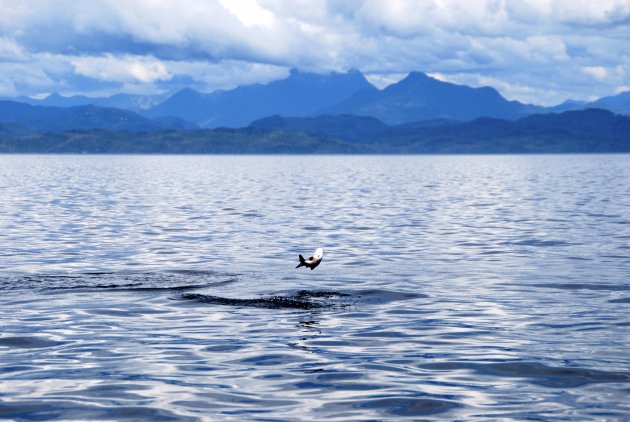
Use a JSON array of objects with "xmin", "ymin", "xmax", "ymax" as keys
[{"xmin": 0, "ymin": 0, "xmax": 630, "ymax": 105}]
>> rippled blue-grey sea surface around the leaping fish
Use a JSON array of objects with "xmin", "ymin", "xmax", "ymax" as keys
[{"xmin": 0, "ymin": 155, "xmax": 630, "ymax": 421}]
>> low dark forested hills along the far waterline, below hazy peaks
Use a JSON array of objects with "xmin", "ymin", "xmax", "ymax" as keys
[{"xmin": 0, "ymin": 109, "xmax": 630, "ymax": 155}]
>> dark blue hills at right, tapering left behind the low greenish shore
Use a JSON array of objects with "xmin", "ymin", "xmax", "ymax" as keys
[{"xmin": 251, "ymin": 109, "xmax": 630, "ymax": 153}]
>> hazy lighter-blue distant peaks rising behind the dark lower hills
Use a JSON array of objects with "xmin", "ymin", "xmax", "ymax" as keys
[{"xmin": 0, "ymin": 69, "xmax": 630, "ymax": 128}]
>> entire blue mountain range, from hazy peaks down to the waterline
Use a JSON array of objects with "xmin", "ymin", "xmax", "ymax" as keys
[{"xmin": 0, "ymin": 69, "xmax": 630, "ymax": 153}]
